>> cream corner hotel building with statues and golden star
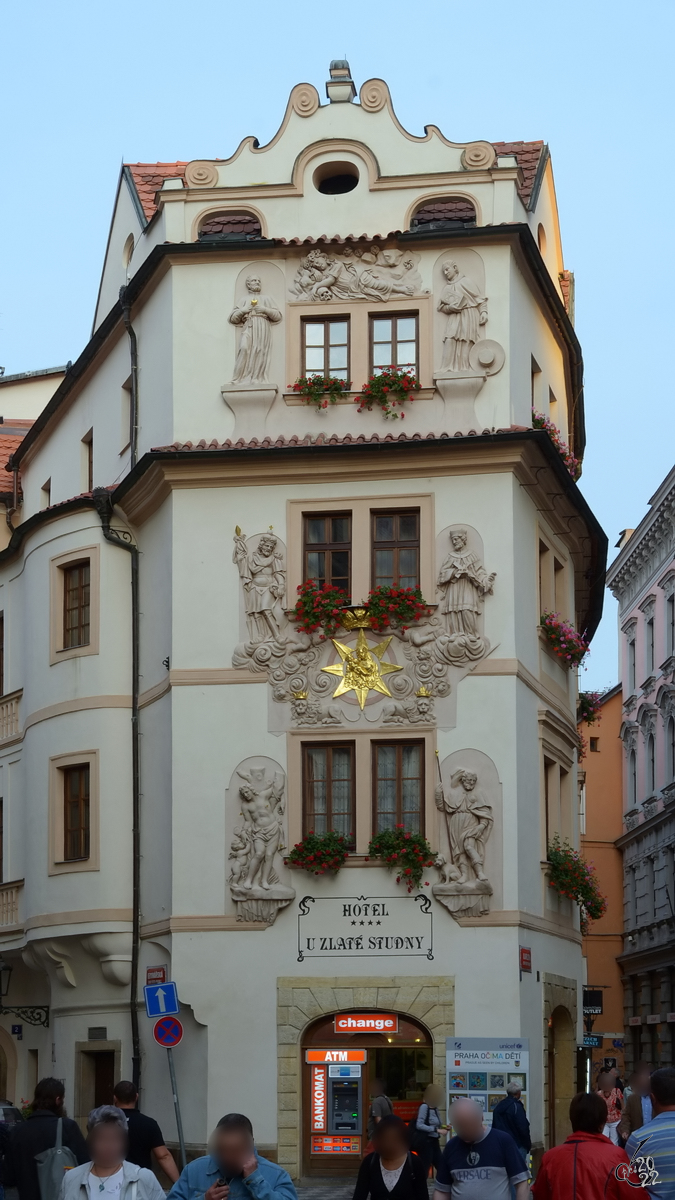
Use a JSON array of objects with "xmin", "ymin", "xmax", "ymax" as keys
[{"xmin": 0, "ymin": 62, "xmax": 607, "ymax": 1175}]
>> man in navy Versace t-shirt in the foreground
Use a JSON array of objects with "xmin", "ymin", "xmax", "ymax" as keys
[{"xmin": 434, "ymin": 1097, "xmax": 530, "ymax": 1200}]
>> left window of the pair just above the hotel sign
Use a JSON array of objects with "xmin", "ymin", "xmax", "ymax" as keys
[{"xmin": 303, "ymin": 742, "xmax": 356, "ymax": 848}]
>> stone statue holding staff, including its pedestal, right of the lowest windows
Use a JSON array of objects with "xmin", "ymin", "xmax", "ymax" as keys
[{"xmin": 432, "ymin": 768, "xmax": 494, "ymax": 917}]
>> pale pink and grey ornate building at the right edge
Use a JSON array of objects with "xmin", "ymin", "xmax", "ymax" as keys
[{"xmin": 608, "ymin": 470, "xmax": 675, "ymax": 1069}]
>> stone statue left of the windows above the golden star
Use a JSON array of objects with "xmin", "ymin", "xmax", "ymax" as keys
[{"xmin": 232, "ymin": 526, "xmax": 286, "ymax": 644}]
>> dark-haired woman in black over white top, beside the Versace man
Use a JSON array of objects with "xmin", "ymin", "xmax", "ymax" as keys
[{"xmin": 353, "ymin": 1116, "xmax": 429, "ymax": 1200}]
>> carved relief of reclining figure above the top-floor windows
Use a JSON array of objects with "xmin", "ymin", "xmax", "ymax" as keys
[{"xmin": 291, "ymin": 246, "xmax": 423, "ymax": 301}]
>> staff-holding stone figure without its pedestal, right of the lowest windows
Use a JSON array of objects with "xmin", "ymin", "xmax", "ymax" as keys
[{"xmin": 436, "ymin": 770, "xmax": 492, "ymax": 883}]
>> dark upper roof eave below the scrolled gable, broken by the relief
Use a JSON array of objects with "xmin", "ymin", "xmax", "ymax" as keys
[{"xmin": 11, "ymin": 223, "xmax": 586, "ymax": 466}]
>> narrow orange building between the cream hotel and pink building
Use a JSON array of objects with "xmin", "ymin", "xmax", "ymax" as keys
[{"xmin": 579, "ymin": 684, "xmax": 625, "ymax": 1084}]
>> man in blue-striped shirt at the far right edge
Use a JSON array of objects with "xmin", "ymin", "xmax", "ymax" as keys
[{"xmin": 626, "ymin": 1067, "xmax": 675, "ymax": 1200}]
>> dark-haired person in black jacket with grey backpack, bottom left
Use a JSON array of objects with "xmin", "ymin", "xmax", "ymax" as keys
[{"xmin": 5, "ymin": 1079, "xmax": 90, "ymax": 1200}]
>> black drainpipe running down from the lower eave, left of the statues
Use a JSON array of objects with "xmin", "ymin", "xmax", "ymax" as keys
[{"xmin": 92, "ymin": 487, "xmax": 141, "ymax": 1091}]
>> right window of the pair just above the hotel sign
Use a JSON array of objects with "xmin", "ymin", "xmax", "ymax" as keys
[{"xmin": 372, "ymin": 742, "xmax": 424, "ymax": 833}]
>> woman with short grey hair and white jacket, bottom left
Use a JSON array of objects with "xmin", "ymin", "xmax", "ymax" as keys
[{"xmin": 59, "ymin": 1104, "xmax": 165, "ymax": 1200}]
